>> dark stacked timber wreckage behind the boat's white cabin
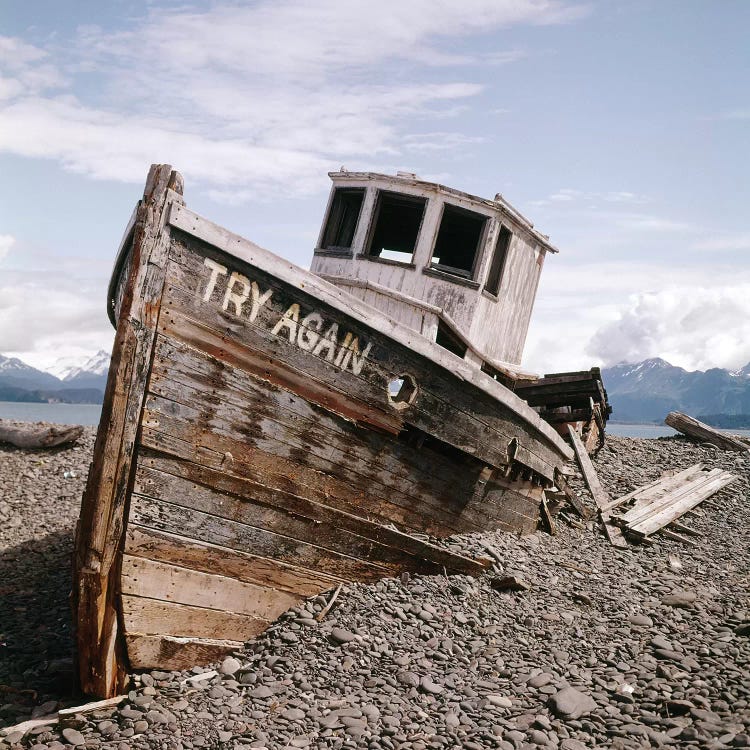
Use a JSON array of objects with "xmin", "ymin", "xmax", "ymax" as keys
[{"xmin": 513, "ymin": 367, "xmax": 612, "ymax": 453}]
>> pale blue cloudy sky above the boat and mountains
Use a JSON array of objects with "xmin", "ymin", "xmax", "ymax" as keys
[{"xmin": 0, "ymin": 0, "xmax": 750, "ymax": 372}]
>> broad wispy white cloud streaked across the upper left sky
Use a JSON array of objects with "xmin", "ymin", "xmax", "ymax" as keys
[{"xmin": 0, "ymin": 0, "xmax": 586, "ymax": 202}]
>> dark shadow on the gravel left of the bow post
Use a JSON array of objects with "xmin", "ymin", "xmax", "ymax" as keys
[{"xmin": 0, "ymin": 528, "xmax": 81, "ymax": 727}]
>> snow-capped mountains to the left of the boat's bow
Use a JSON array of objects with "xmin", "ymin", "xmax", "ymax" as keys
[{"xmin": 0, "ymin": 351, "xmax": 109, "ymax": 404}]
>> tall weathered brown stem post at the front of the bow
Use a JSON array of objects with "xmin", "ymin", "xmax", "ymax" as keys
[{"xmin": 73, "ymin": 164, "xmax": 182, "ymax": 697}]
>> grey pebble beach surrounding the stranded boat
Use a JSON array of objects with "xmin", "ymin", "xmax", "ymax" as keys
[{"xmin": 0, "ymin": 428, "xmax": 750, "ymax": 750}]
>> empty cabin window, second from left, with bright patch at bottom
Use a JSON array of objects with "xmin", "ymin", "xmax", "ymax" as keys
[{"xmin": 366, "ymin": 192, "xmax": 427, "ymax": 263}]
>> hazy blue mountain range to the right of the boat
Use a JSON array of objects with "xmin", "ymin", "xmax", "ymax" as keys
[{"xmin": 602, "ymin": 357, "xmax": 750, "ymax": 428}]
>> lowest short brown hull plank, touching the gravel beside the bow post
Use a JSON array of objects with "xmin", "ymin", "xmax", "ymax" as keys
[{"xmin": 125, "ymin": 633, "xmax": 243, "ymax": 670}]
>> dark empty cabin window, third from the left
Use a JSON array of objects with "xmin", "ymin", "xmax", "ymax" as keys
[{"xmin": 430, "ymin": 203, "xmax": 487, "ymax": 279}]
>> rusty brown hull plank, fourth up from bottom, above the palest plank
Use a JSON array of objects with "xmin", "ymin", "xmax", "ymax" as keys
[{"xmin": 124, "ymin": 522, "xmax": 343, "ymax": 596}]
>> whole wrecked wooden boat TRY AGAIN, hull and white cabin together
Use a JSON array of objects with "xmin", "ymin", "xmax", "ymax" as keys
[{"xmin": 73, "ymin": 165, "xmax": 609, "ymax": 696}]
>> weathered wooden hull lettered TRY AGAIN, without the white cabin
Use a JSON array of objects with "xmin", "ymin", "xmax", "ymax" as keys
[{"xmin": 74, "ymin": 166, "xmax": 570, "ymax": 695}]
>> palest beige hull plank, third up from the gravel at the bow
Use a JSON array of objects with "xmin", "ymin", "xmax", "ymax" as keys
[{"xmin": 120, "ymin": 555, "xmax": 300, "ymax": 622}]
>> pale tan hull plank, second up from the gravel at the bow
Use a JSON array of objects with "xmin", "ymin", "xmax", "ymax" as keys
[{"xmin": 121, "ymin": 594, "xmax": 268, "ymax": 641}]
